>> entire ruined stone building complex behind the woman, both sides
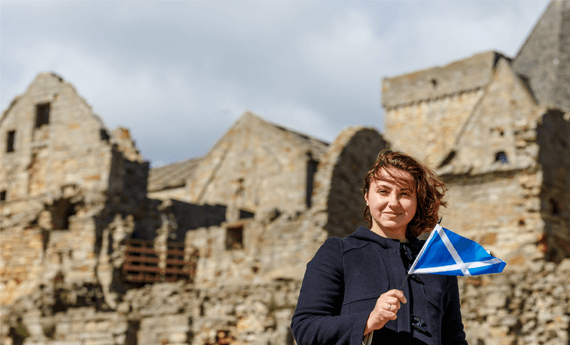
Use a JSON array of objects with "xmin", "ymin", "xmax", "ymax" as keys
[{"xmin": 0, "ymin": 0, "xmax": 570, "ymax": 345}]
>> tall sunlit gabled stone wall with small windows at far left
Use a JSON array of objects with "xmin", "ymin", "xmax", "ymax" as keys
[{"xmin": 0, "ymin": 73, "xmax": 151, "ymax": 328}]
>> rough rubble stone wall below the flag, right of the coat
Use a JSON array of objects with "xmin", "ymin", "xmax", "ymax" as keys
[{"xmin": 459, "ymin": 259, "xmax": 570, "ymax": 345}]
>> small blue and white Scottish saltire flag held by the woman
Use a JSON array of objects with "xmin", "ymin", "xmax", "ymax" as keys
[{"xmin": 408, "ymin": 224, "xmax": 507, "ymax": 276}]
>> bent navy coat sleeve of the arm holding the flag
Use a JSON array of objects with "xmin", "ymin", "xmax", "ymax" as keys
[{"xmin": 291, "ymin": 238, "xmax": 369, "ymax": 345}]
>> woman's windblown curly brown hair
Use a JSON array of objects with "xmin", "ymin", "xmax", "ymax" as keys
[{"xmin": 361, "ymin": 150, "xmax": 447, "ymax": 238}]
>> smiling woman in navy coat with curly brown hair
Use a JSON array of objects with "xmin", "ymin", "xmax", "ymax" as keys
[{"xmin": 291, "ymin": 150, "xmax": 467, "ymax": 345}]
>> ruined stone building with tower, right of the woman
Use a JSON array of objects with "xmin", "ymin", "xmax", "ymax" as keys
[{"xmin": 382, "ymin": 1, "xmax": 570, "ymax": 344}]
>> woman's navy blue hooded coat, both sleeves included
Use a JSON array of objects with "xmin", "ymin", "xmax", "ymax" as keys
[{"xmin": 291, "ymin": 227, "xmax": 467, "ymax": 345}]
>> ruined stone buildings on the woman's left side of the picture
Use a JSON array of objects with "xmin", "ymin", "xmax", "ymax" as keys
[{"xmin": 0, "ymin": 73, "xmax": 386, "ymax": 345}]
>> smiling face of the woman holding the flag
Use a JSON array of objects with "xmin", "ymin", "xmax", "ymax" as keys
[{"xmin": 364, "ymin": 167, "xmax": 417, "ymax": 241}]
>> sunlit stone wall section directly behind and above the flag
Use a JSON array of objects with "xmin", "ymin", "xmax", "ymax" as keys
[{"xmin": 440, "ymin": 171, "xmax": 544, "ymax": 270}]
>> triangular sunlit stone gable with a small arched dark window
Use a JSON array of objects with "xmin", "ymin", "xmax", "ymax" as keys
[{"xmin": 439, "ymin": 59, "xmax": 546, "ymax": 176}]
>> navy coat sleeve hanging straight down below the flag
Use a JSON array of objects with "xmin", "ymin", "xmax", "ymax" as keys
[{"xmin": 441, "ymin": 277, "xmax": 467, "ymax": 345}]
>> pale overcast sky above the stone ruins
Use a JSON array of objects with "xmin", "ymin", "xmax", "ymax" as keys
[{"xmin": 0, "ymin": 0, "xmax": 548, "ymax": 166}]
